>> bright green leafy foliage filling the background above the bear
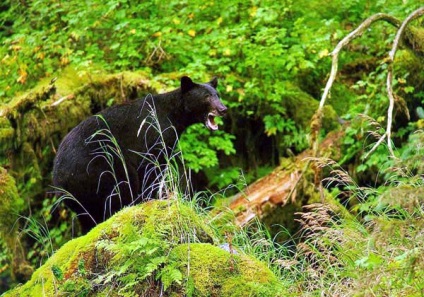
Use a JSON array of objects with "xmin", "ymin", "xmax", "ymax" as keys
[{"xmin": 0, "ymin": 0, "xmax": 419, "ymax": 184}]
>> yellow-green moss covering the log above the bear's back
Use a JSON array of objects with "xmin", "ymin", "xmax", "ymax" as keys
[{"xmin": 0, "ymin": 67, "xmax": 156, "ymax": 164}]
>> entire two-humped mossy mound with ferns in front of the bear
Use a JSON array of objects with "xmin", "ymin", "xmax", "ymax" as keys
[{"xmin": 5, "ymin": 200, "xmax": 280, "ymax": 296}]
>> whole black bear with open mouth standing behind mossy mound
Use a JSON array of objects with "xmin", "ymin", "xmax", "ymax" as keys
[{"xmin": 53, "ymin": 76, "xmax": 227, "ymax": 233}]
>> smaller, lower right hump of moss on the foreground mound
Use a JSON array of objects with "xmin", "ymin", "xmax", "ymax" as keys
[{"xmin": 166, "ymin": 243, "xmax": 282, "ymax": 297}]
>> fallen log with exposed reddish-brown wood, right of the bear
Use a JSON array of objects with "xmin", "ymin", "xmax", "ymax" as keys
[{"xmin": 229, "ymin": 129, "xmax": 344, "ymax": 226}]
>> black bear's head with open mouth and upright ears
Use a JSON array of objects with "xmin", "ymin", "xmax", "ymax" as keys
[{"xmin": 181, "ymin": 76, "xmax": 227, "ymax": 130}]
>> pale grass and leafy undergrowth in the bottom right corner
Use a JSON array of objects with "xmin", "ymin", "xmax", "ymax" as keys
[{"xmin": 290, "ymin": 143, "xmax": 424, "ymax": 296}]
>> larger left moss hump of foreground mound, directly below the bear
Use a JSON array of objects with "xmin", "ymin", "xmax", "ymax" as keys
[{"xmin": 2, "ymin": 201, "xmax": 222, "ymax": 296}]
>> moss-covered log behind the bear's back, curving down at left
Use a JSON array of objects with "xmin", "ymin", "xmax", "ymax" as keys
[{"xmin": 0, "ymin": 68, "xmax": 158, "ymax": 196}]
